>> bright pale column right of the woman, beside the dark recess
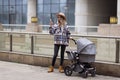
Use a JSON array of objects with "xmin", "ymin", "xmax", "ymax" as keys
[{"xmin": 75, "ymin": 0, "xmax": 88, "ymax": 34}]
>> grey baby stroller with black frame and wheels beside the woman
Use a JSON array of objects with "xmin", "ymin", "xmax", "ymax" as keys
[{"xmin": 64, "ymin": 38, "xmax": 96, "ymax": 78}]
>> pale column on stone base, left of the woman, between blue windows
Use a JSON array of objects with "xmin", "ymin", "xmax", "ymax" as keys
[{"xmin": 26, "ymin": 0, "xmax": 41, "ymax": 32}]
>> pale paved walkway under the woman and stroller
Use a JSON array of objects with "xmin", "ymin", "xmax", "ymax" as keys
[{"xmin": 0, "ymin": 61, "xmax": 120, "ymax": 80}]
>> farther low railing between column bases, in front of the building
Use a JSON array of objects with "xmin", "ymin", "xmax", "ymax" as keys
[{"xmin": 2, "ymin": 24, "xmax": 98, "ymax": 35}]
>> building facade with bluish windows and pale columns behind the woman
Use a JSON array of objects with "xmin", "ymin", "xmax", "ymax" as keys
[{"xmin": 0, "ymin": 0, "xmax": 120, "ymax": 27}]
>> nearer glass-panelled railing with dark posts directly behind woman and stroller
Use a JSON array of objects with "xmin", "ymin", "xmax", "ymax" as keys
[{"xmin": 0, "ymin": 31, "xmax": 120, "ymax": 63}]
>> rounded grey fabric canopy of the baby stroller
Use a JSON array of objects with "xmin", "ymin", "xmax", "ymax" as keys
[{"xmin": 76, "ymin": 38, "xmax": 96, "ymax": 55}]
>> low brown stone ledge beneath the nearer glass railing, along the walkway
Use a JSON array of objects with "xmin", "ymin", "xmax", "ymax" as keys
[{"xmin": 0, "ymin": 52, "xmax": 120, "ymax": 77}]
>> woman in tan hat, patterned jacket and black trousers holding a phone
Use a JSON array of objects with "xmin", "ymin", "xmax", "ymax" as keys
[{"xmin": 48, "ymin": 12, "xmax": 70, "ymax": 73}]
